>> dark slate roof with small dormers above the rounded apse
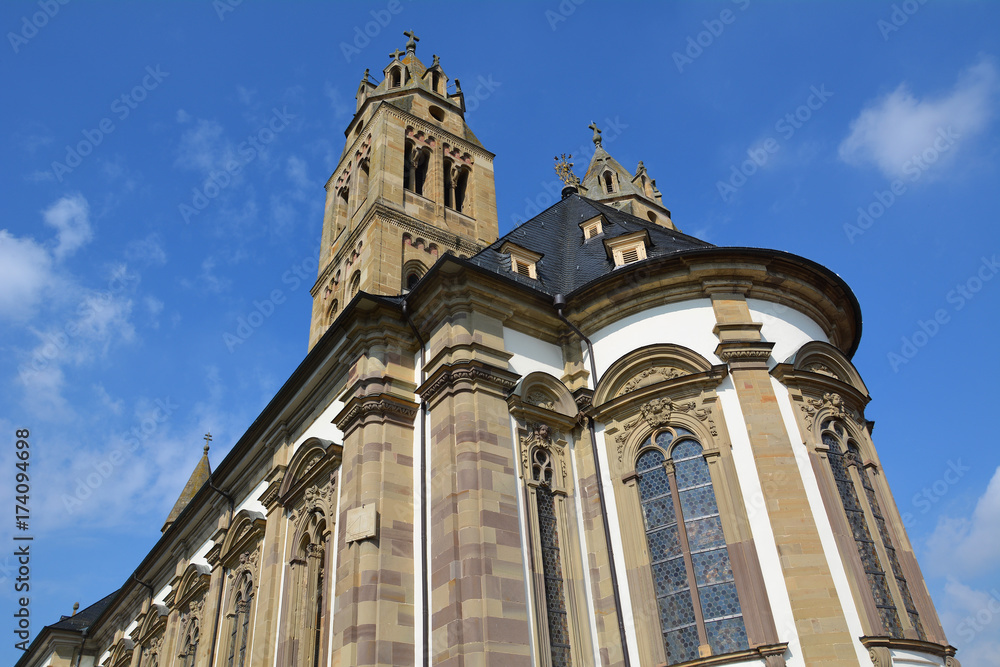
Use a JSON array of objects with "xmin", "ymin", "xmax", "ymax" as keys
[{"xmin": 469, "ymin": 194, "xmax": 715, "ymax": 295}]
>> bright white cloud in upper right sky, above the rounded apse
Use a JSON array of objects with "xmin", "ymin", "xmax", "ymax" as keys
[{"xmin": 840, "ymin": 58, "xmax": 1000, "ymax": 178}]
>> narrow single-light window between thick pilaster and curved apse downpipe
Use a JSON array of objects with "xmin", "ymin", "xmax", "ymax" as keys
[{"xmin": 531, "ymin": 447, "xmax": 572, "ymax": 667}]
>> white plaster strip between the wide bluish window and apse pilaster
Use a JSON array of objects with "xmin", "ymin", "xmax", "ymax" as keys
[{"xmin": 718, "ymin": 375, "xmax": 808, "ymax": 667}]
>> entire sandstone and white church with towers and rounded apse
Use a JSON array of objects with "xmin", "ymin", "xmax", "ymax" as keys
[{"xmin": 18, "ymin": 32, "xmax": 959, "ymax": 667}]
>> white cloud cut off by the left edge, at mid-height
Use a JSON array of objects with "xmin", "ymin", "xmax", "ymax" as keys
[{"xmin": 0, "ymin": 229, "xmax": 52, "ymax": 320}]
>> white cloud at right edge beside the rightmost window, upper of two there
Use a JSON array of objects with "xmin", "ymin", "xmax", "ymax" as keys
[{"xmin": 927, "ymin": 467, "xmax": 1000, "ymax": 576}]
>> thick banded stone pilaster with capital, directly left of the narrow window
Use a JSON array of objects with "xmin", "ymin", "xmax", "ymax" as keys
[{"xmin": 418, "ymin": 361, "xmax": 530, "ymax": 667}]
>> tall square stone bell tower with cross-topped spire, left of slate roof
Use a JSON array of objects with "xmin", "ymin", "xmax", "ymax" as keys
[{"xmin": 309, "ymin": 31, "xmax": 498, "ymax": 349}]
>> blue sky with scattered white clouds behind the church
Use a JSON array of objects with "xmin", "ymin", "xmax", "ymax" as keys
[{"xmin": 0, "ymin": 0, "xmax": 1000, "ymax": 667}]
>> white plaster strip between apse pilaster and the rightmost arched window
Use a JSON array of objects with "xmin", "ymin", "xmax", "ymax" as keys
[{"xmin": 768, "ymin": 378, "xmax": 869, "ymax": 665}]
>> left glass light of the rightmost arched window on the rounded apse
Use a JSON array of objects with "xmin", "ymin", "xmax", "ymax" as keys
[{"xmin": 823, "ymin": 424, "xmax": 903, "ymax": 638}]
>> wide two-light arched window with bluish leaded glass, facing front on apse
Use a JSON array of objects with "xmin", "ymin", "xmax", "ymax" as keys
[{"xmin": 636, "ymin": 428, "xmax": 749, "ymax": 665}]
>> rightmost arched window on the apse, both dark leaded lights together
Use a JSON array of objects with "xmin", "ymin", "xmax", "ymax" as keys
[{"xmin": 823, "ymin": 420, "xmax": 924, "ymax": 639}]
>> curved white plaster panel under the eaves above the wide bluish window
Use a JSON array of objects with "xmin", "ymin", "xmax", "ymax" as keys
[{"xmin": 584, "ymin": 299, "xmax": 721, "ymax": 377}]
